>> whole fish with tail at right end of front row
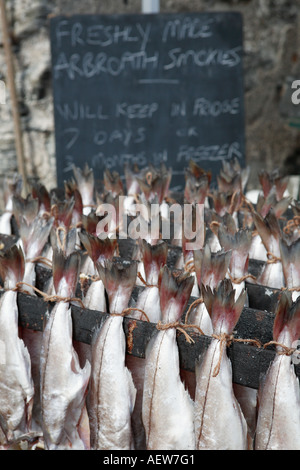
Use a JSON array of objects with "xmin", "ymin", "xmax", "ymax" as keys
[{"xmin": 255, "ymin": 292, "xmax": 300, "ymax": 450}]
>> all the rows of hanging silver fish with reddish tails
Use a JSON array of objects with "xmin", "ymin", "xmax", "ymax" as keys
[{"xmin": 0, "ymin": 162, "xmax": 300, "ymax": 450}]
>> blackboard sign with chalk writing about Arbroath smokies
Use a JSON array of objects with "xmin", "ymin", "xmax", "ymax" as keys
[{"xmin": 50, "ymin": 12, "xmax": 245, "ymax": 190}]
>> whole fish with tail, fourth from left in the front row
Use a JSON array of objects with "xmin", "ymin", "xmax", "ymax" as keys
[{"xmin": 142, "ymin": 267, "xmax": 195, "ymax": 450}]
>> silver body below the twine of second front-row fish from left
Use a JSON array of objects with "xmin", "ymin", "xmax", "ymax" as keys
[{"xmin": 40, "ymin": 302, "xmax": 91, "ymax": 450}]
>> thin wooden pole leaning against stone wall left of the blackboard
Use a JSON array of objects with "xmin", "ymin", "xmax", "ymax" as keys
[{"xmin": 0, "ymin": 0, "xmax": 27, "ymax": 191}]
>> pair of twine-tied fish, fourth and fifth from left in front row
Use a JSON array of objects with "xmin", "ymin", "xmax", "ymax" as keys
[{"xmin": 142, "ymin": 267, "xmax": 248, "ymax": 450}]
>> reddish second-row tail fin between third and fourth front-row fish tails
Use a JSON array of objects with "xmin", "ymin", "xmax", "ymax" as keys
[{"xmin": 140, "ymin": 239, "xmax": 168, "ymax": 284}]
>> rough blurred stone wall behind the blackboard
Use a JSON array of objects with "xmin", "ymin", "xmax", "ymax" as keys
[{"xmin": 0, "ymin": 0, "xmax": 300, "ymax": 207}]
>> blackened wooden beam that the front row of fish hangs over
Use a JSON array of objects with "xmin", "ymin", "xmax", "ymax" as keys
[{"xmin": 11, "ymin": 292, "xmax": 300, "ymax": 389}]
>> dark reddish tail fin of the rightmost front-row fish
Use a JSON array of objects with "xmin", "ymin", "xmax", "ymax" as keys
[{"xmin": 273, "ymin": 291, "xmax": 300, "ymax": 346}]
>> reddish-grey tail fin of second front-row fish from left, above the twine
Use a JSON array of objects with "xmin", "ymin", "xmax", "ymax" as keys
[{"xmin": 52, "ymin": 249, "xmax": 80, "ymax": 297}]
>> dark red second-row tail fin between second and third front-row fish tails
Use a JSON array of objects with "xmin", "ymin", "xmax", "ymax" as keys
[{"xmin": 79, "ymin": 229, "xmax": 118, "ymax": 263}]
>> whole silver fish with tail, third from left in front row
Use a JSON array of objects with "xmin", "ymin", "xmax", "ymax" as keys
[{"xmin": 88, "ymin": 262, "xmax": 136, "ymax": 450}]
